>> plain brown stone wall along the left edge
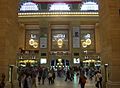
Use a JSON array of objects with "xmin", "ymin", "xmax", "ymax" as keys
[{"xmin": 0, "ymin": 0, "xmax": 18, "ymax": 81}]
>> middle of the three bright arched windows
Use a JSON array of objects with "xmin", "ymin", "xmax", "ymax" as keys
[{"xmin": 49, "ymin": 3, "xmax": 70, "ymax": 11}]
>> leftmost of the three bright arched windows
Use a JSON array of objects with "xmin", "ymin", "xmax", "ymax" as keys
[{"xmin": 20, "ymin": 2, "xmax": 39, "ymax": 11}]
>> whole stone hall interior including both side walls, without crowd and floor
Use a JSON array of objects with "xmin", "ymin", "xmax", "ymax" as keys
[{"xmin": 0, "ymin": 0, "xmax": 120, "ymax": 88}]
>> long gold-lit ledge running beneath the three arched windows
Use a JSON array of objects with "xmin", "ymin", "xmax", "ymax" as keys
[{"xmin": 18, "ymin": 11, "xmax": 99, "ymax": 17}]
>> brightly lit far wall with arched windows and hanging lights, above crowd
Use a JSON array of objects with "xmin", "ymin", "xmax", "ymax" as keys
[{"xmin": 17, "ymin": 1, "xmax": 100, "ymax": 67}]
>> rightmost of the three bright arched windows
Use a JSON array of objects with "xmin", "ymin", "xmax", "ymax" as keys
[{"xmin": 80, "ymin": 2, "xmax": 98, "ymax": 11}]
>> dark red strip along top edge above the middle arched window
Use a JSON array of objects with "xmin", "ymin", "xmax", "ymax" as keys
[{"xmin": 32, "ymin": 0, "xmax": 82, "ymax": 3}]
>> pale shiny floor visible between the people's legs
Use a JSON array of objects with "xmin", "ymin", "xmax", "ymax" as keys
[{"xmin": 34, "ymin": 76, "xmax": 96, "ymax": 88}]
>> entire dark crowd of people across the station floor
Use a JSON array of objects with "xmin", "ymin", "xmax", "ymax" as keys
[{"xmin": 18, "ymin": 65, "xmax": 102, "ymax": 88}]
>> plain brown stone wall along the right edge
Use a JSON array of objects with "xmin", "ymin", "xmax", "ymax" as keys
[{"xmin": 99, "ymin": 0, "xmax": 120, "ymax": 88}]
